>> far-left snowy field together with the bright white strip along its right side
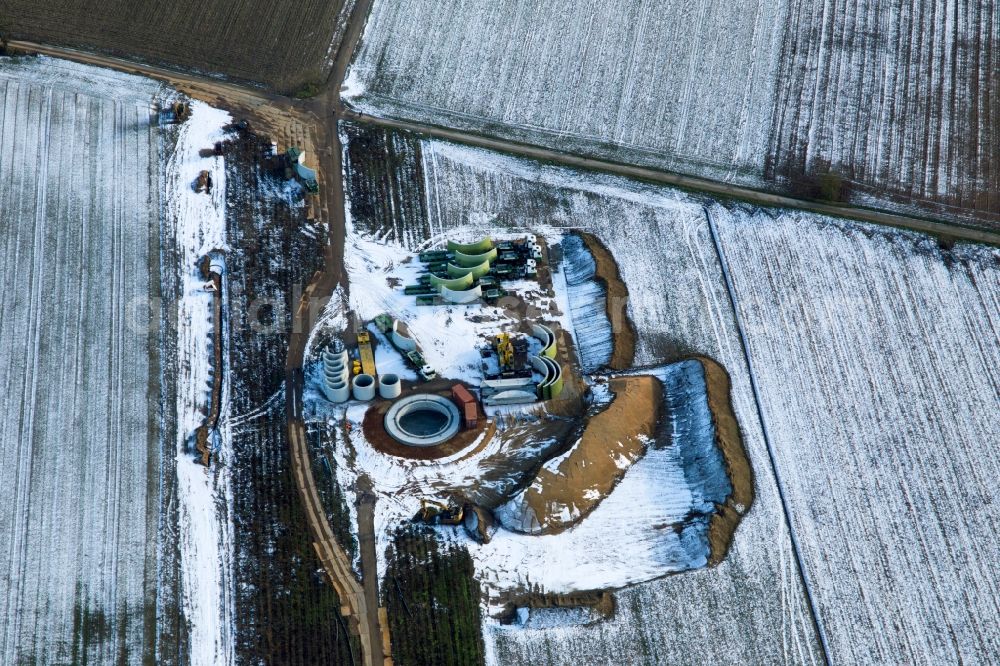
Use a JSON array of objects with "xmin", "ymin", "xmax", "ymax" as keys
[{"xmin": 0, "ymin": 58, "xmax": 242, "ymax": 664}]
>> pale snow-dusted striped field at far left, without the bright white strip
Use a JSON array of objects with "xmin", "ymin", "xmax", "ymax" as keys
[{"xmin": 0, "ymin": 59, "xmax": 169, "ymax": 664}]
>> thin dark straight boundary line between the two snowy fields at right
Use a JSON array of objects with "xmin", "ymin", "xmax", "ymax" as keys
[{"xmin": 702, "ymin": 206, "xmax": 831, "ymax": 666}]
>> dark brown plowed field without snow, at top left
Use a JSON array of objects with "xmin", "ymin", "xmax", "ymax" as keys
[{"xmin": 3, "ymin": 0, "xmax": 354, "ymax": 92}]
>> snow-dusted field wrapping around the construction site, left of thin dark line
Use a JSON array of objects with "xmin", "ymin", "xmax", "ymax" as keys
[{"xmin": 340, "ymin": 134, "xmax": 821, "ymax": 664}]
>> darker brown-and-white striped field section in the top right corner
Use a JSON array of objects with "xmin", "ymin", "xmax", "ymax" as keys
[{"xmin": 768, "ymin": 0, "xmax": 1000, "ymax": 226}]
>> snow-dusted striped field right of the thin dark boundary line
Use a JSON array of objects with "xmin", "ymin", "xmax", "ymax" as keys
[{"xmin": 712, "ymin": 208, "xmax": 1000, "ymax": 663}]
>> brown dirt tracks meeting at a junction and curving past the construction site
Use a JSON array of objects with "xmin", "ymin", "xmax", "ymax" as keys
[{"xmin": 10, "ymin": 0, "xmax": 1000, "ymax": 666}]
